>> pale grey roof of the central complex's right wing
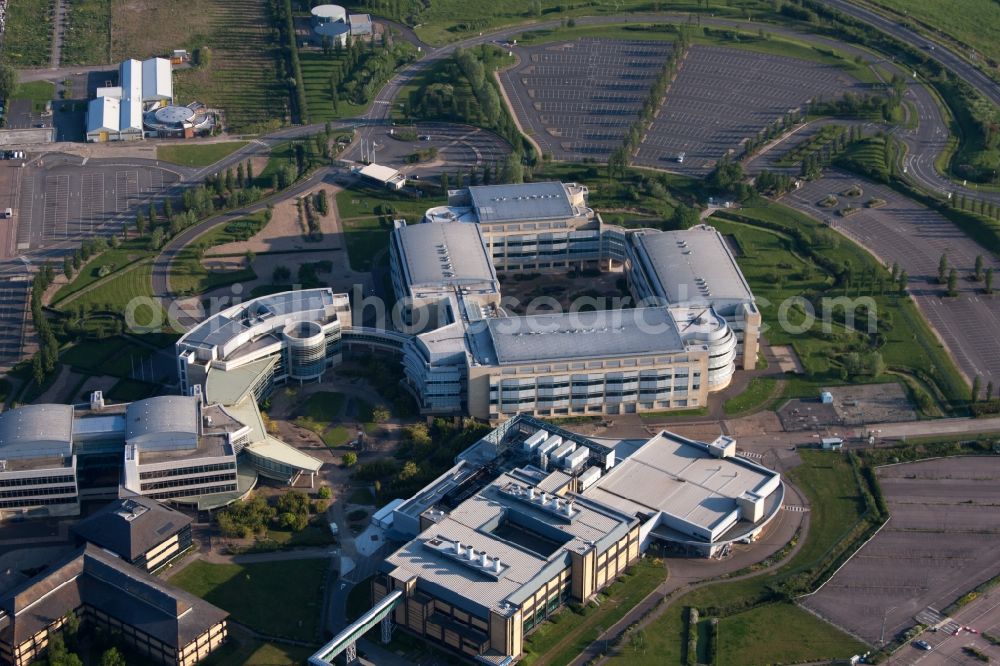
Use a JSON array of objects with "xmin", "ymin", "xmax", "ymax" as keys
[{"xmin": 632, "ymin": 225, "xmax": 753, "ymax": 305}]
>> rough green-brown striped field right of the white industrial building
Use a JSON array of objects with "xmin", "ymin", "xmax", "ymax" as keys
[{"xmin": 174, "ymin": 0, "xmax": 289, "ymax": 132}]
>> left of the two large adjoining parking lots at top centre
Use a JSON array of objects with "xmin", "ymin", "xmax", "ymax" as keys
[{"xmin": 500, "ymin": 39, "xmax": 671, "ymax": 160}]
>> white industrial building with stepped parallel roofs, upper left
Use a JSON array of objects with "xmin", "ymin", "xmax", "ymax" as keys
[{"xmin": 87, "ymin": 58, "xmax": 174, "ymax": 142}]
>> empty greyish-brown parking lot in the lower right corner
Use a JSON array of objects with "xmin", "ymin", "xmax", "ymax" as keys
[{"xmin": 803, "ymin": 457, "xmax": 1000, "ymax": 645}]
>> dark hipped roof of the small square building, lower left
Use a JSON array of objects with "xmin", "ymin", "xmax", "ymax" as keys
[{"xmin": 73, "ymin": 497, "xmax": 191, "ymax": 560}]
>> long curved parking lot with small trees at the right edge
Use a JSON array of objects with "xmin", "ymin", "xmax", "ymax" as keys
[{"xmin": 783, "ymin": 169, "xmax": 1000, "ymax": 385}]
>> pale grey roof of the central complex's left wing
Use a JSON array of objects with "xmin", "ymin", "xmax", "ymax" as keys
[{"xmin": 394, "ymin": 222, "xmax": 497, "ymax": 287}]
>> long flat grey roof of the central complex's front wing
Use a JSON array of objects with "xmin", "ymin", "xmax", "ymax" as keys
[{"xmin": 476, "ymin": 308, "xmax": 684, "ymax": 364}]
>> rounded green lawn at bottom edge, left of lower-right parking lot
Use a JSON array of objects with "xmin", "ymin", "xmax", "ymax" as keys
[{"xmin": 716, "ymin": 603, "xmax": 867, "ymax": 666}]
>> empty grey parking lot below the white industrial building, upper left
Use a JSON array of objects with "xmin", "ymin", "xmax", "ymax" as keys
[{"xmin": 15, "ymin": 158, "xmax": 180, "ymax": 251}]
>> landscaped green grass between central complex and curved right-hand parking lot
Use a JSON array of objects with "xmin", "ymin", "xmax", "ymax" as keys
[{"xmin": 711, "ymin": 197, "xmax": 967, "ymax": 403}]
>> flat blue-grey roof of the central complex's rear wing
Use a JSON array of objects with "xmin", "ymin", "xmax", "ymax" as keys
[{"xmin": 469, "ymin": 182, "xmax": 576, "ymax": 222}]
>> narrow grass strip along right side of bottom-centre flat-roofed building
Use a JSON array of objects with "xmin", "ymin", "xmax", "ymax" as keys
[{"xmin": 519, "ymin": 559, "xmax": 666, "ymax": 666}]
